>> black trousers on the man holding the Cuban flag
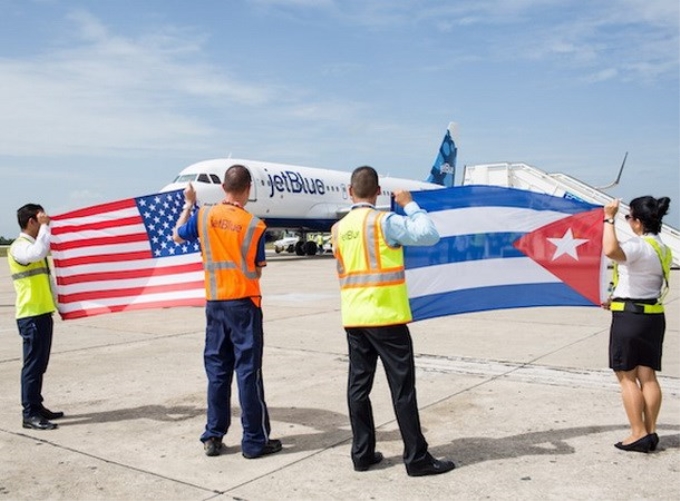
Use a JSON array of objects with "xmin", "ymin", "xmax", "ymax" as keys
[{"xmin": 345, "ymin": 325, "xmax": 429, "ymax": 465}]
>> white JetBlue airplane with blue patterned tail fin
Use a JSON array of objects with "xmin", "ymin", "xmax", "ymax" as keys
[{"xmin": 161, "ymin": 122, "xmax": 458, "ymax": 256}]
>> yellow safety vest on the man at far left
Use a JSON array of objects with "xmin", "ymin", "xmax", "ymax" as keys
[{"xmin": 7, "ymin": 237, "xmax": 56, "ymax": 318}]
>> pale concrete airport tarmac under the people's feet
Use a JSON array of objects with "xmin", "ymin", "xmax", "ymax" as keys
[{"xmin": 0, "ymin": 254, "xmax": 680, "ymax": 501}]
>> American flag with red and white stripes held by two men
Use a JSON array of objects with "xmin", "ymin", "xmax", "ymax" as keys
[{"xmin": 50, "ymin": 190, "xmax": 205, "ymax": 320}]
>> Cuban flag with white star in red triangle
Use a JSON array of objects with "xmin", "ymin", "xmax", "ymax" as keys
[{"xmin": 404, "ymin": 186, "xmax": 607, "ymax": 320}]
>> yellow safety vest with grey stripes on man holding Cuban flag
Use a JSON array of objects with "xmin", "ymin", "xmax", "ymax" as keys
[{"xmin": 331, "ymin": 208, "xmax": 411, "ymax": 327}]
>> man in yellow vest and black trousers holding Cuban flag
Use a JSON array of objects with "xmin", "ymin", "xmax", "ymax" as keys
[{"xmin": 332, "ymin": 166, "xmax": 455, "ymax": 476}]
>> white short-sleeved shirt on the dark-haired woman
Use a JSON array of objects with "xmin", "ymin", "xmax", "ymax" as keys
[{"xmin": 614, "ymin": 234, "xmax": 664, "ymax": 299}]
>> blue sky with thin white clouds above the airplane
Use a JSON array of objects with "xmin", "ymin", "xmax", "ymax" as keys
[{"xmin": 0, "ymin": 0, "xmax": 680, "ymax": 238}]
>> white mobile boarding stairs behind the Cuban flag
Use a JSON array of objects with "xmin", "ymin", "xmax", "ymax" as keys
[{"xmin": 463, "ymin": 163, "xmax": 680, "ymax": 268}]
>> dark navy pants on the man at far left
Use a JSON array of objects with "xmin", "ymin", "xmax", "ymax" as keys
[{"xmin": 17, "ymin": 313, "xmax": 54, "ymax": 418}]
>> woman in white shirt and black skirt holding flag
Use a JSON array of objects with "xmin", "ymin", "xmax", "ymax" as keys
[{"xmin": 603, "ymin": 196, "xmax": 671, "ymax": 452}]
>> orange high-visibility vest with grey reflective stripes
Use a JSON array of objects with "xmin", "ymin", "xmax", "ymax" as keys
[{"xmin": 198, "ymin": 204, "xmax": 265, "ymax": 300}]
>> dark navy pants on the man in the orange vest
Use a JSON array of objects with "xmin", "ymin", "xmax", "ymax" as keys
[{"xmin": 201, "ymin": 298, "xmax": 271, "ymax": 455}]
